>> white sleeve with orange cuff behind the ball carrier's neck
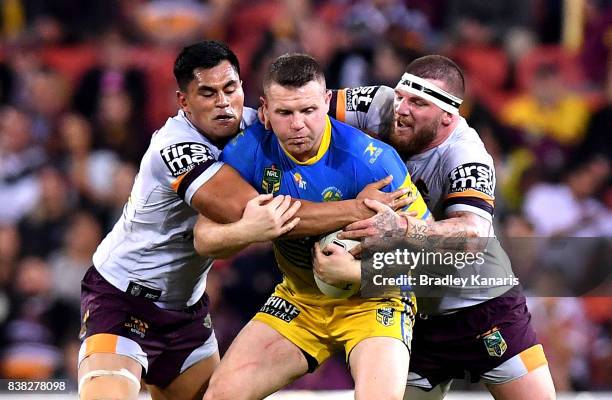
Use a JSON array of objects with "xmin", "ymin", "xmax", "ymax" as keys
[{"xmin": 329, "ymin": 86, "xmax": 394, "ymax": 137}]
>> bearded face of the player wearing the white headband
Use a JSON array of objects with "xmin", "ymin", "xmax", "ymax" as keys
[{"xmin": 389, "ymin": 80, "xmax": 445, "ymax": 156}]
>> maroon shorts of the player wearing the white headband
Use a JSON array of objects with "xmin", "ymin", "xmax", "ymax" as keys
[{"xmin": 408, "ymin": 289, "xmax": 545, "ymax": 387}]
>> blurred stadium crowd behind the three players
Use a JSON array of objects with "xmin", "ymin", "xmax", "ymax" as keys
[{"xmin": 0, "ymin": 0, "xmax": 612, "ymax": 390}]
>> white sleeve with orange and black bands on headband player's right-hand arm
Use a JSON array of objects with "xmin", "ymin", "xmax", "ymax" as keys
[{"xmin": 441, "ymin": 143, "xmax": 495, "ymax": 220}]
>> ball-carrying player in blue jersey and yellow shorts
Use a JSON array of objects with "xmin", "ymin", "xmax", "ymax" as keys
[{"xmin": 196, "ymin": 55, "xmax": 429, "ymax": 400}]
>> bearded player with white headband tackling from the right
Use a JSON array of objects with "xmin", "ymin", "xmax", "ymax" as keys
[{"xmin": 314, "ymin": 55, "xmax": 555, "ymax": 400}]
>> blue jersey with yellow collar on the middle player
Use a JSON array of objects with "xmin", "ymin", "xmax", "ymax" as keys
[{"xmin": 220, "ymin": 117, "xmax": 429, "ymax": 295}]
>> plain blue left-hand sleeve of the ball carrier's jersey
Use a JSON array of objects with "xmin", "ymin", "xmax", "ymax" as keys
[{"xmin": 220, "ymin": 122, "xmax": 263, "ymax": 186}]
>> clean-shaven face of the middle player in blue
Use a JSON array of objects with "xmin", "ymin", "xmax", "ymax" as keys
[{"xmin": 264, "ymin": 81, "xmax": 331, "ymax": 161}]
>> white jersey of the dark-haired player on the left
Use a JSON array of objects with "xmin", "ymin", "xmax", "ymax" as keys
[{"xmin": 93, "ymin": 107, "xmax": 257, "ymax": 309}]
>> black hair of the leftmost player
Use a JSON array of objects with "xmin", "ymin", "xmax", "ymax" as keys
[{"xmin": 174, "ymin": 40, "xmax": 240, "ymax": 91}]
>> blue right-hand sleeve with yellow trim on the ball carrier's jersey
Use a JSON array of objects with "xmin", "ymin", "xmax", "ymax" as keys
[{"xmin": 357, "ymin": 141, "xmax": 431, "ymax": 220}]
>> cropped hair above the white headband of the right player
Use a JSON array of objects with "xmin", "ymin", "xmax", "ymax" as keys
[{"xmin": 406, "ymin": 55, "xmax": 465, "ymax": 99}]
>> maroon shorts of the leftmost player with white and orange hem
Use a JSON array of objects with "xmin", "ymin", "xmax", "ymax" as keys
[{"xmin": 79, "ymin": 267, "xmax": 217, "ymax": 388}]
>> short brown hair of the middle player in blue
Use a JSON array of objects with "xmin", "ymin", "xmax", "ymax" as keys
[{"xmin": 263, "ymin": 54, "xmax": 325, "ymax": 92}]
